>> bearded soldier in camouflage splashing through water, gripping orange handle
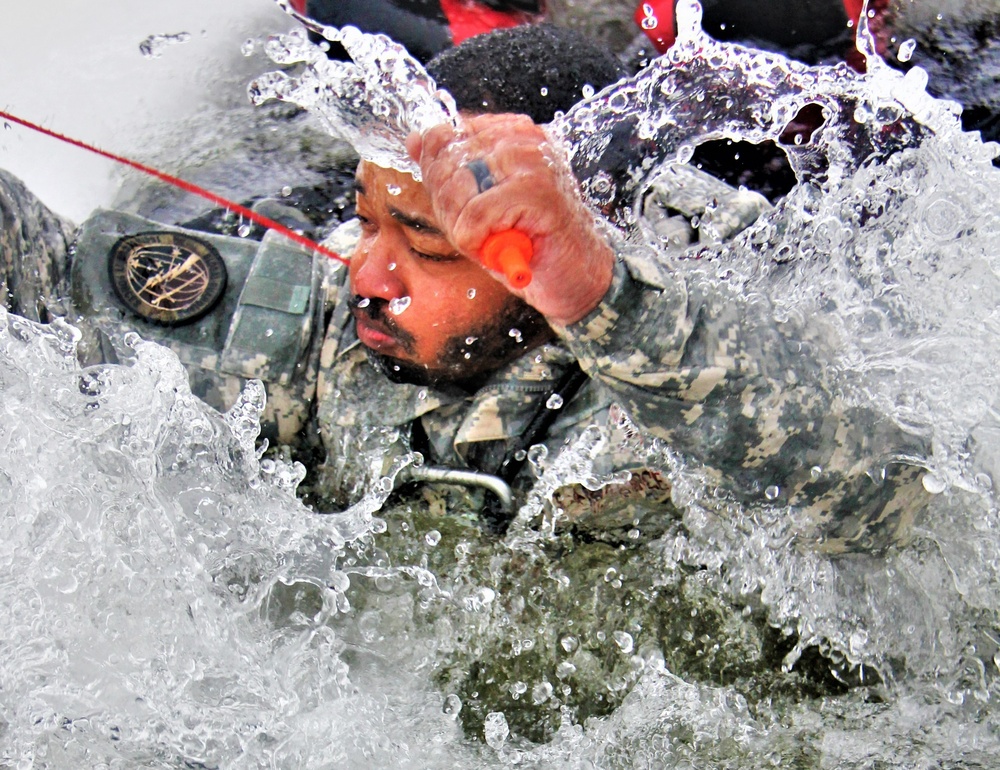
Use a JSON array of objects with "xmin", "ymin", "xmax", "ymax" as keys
[{"xmin": 0, "ymin": 25, "xmax": 923, "ymax": 550}]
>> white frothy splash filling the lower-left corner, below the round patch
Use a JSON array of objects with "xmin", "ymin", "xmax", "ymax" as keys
[{"xmin": 0, "ymin": 310, "xmax": 464, "ymax": 768}]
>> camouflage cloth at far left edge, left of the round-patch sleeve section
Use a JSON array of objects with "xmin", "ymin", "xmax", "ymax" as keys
[{"xmin": 0, "ymin": 169, "xmax": 73, "ymax": 322}]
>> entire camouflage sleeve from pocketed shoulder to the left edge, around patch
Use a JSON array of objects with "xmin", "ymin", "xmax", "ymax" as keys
[{"xmin": 0, "ymin": 170, "xmax": 330, "ymax": 443}]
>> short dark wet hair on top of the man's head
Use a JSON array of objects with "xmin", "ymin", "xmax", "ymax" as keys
[{"xmin": 427, "ymin": 24, "xmax": 628, "ymax": 123}]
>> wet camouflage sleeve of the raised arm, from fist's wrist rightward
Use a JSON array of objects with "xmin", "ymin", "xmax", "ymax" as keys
[{"xmin": 557, "ymin": 247, "xmax": 924, "ymax": 550}]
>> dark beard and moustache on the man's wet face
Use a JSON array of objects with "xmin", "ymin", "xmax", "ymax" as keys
[{"xmin": 351, "ymin": 296, "xmax": 553, "ymax": 393}]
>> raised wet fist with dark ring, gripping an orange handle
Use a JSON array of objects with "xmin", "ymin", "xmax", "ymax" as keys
[{"xmin": 407, "ymin": 115, "xmax": 615, "ymax": 326}]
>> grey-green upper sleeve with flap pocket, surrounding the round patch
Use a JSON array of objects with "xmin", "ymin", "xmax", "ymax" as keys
[{"xmin": 71, "ymin": 211, "xmax": 329, "ymax": 444}]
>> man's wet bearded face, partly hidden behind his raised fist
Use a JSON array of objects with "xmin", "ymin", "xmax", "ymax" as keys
[{"xmin": 350, "ymin": 161, "xmax": 551, "ymax": 384}]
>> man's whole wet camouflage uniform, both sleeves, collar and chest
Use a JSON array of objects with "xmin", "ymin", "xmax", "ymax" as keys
[{"xmin": 0, "ymin": 169, "xmax": 922, "ymax": 550}]
